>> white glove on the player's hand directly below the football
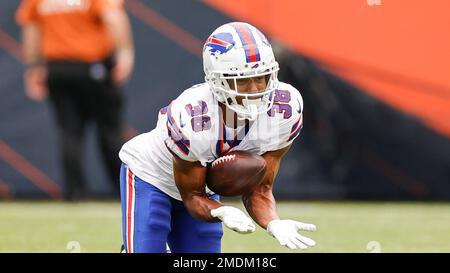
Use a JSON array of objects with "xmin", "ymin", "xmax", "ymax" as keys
[{"xmin": 211, "ymin": 206, "xmax": 255, "ymax": 233}]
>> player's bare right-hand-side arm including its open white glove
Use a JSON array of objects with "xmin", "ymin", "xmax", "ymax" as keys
[{"xmin": 242, "ymin": 144, "xmax": 316, "ymax": 249}]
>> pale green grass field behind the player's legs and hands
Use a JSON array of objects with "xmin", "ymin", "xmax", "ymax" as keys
[{"xmin": 0, "ymin": 200, "xmax": 450, "ymax": 253}]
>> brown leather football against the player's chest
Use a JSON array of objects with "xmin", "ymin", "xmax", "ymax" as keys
[{"xmin": 206, "ymin": 151, "xmax": 266, "ymax": 196}]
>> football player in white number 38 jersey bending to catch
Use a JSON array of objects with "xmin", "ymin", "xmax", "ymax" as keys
[{"xmin": 119, "ymin": 22, "xmax": 315, "ymax": 253}]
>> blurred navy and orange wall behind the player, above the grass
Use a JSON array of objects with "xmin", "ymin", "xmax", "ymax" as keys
[{"xmin": 0, "ymin": 0, "xmax": 450, "ymax": 200}]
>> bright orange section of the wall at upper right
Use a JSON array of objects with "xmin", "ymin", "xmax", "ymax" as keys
[{"xmin": 204, "ymin": 0, "xmax": 450, "ymax": 136}]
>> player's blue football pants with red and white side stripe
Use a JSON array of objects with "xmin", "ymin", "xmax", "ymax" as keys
[{"xmin": 120, "ymin": 164, "xmax": 223, "ymax": 253}]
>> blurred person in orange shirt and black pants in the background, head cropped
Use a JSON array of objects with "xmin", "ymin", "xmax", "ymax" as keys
[{"xmin": 16, "ymin": 0, "xmax": 134, "ymax": 200}]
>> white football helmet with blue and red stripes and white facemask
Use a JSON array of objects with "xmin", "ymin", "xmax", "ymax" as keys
[{"xmin": 203, "ymin": 22, "xmax": 279, "ymax": 120}]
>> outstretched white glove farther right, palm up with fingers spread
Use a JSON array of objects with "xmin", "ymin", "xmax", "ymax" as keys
[{"xmin": 267, "ymin": 219, "xmax": 316, "ymax": 249}]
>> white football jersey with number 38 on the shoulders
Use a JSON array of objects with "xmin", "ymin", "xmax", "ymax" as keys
[{"xmin": 119, "ymin": 82, "xmax": 303, "ymax": 200}]
